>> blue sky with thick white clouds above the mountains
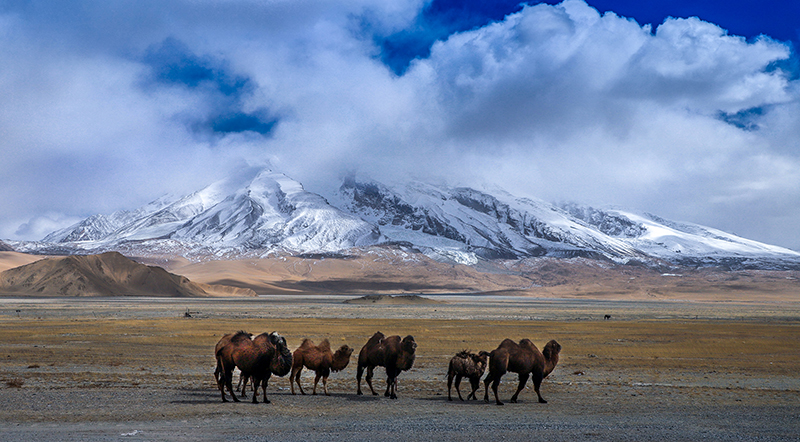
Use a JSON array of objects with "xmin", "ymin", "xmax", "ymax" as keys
[{"xmin": 0, "ymin": 0, "xmax": 800, "ymax": 250}]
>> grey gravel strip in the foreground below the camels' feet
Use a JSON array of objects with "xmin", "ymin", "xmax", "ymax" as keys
[{"xmin": 0, "ymin": 385, "xmax": 800, "ymax": 441}]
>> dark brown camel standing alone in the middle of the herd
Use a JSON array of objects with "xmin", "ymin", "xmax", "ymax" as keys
[{"xmin": 356, "ymin": 332, "xmax": 417, "ymax": 399}]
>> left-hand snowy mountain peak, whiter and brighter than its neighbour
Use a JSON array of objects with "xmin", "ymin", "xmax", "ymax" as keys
[{"xmin": 31, "ymin": 170, "xmax": 380, "ymax": 252}]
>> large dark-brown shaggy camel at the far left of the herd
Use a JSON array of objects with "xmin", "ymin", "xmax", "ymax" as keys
[{"xmin": 216, "ymin": 331, "xmax": 292, "ymax": 404}]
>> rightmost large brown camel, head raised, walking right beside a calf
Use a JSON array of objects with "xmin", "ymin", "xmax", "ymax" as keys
[{"xmin": 483, "ymin": 339, "xmax": 561, "ymax": 405}]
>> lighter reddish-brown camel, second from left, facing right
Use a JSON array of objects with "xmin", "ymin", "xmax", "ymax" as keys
[{"xmin": 289, "ymin": 339, "xmax": 353, "ymax": 396}]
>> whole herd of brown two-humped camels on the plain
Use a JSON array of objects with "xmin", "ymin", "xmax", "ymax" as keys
[{"xmin": 214, "ymin": 331, "xmax": 561, "ymax": 405}]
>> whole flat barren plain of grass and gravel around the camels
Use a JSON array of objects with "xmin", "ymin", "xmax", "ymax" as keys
[{"xmin": 0, "ymin": 296, "xmax": 800, "ymax": 441}]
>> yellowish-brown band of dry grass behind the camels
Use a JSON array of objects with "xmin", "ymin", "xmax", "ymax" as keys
[{"xmin": 0, "ymin": 306, "xmax": 800, "ymax": 391}]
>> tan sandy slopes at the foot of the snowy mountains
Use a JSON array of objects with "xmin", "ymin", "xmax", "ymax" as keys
[{"xmin": 0, "ymin": 248, "xmax": 800, "ymax": 302}]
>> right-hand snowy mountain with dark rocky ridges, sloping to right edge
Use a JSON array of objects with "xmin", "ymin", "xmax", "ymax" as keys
[{"xmin": 332, "ymin": 177, "xmax": 800, "ymax": 266}]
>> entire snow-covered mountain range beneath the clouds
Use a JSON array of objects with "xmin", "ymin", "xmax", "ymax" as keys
[{"xmin": 12, "ymin": 170, "xmax": 800, "ymax": 268}]
